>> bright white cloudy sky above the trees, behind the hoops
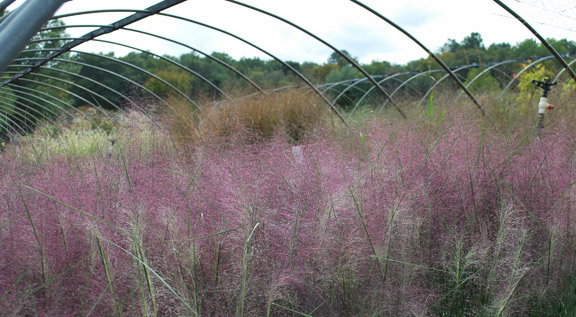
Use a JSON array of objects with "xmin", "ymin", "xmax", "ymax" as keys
[{"xmin": 9, "ymin": 0, "xmax": 576, "ymax": 64}]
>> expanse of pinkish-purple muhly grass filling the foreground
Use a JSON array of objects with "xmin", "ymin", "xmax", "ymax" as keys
[{"xmin": 0, "ymin": 96, "xmax": 576, "ymax": 316}]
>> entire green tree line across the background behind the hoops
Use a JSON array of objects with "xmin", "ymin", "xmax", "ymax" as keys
[{"xmin": 0, "ymin": 14, "xmax": 576, "ymax": 135}]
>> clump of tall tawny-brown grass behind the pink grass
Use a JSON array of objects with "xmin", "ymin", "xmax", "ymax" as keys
[{"xmin": 164, "ymin": 90, "xmax": 330, "ymax": 142}]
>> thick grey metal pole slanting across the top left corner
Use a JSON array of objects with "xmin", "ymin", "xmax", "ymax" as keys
[{"xmin": 0, "ymin": 0, "xmax": 67, "ymax": 73}]
